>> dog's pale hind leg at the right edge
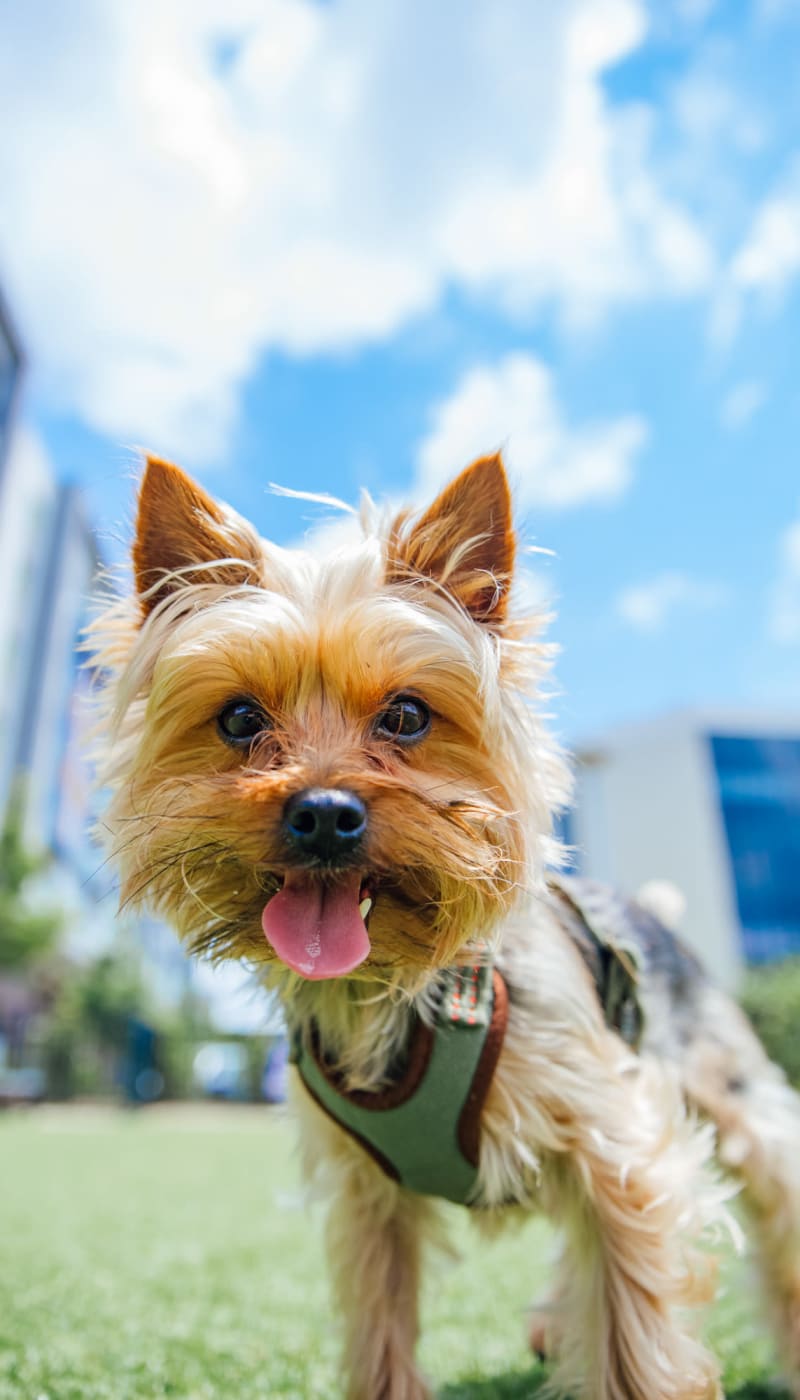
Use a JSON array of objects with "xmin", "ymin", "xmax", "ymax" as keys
[{"xmin": 685, "ymin": 988, "xmax": 800, "ymax": 1394}]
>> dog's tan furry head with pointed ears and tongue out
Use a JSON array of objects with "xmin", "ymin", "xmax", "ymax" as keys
[{"xmin": 95, "ymin": 456, "xmax": 562, "ymax": 980}]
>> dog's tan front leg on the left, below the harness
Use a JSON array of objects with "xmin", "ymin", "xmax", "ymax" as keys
[{"xmin": 298, "ymin": 1095, "xmax": 439, "ymax": 1400}]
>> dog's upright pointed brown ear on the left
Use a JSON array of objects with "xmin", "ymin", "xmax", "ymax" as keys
[{"xmin": 133, "ymin": 456, "xmax": 263, "ymax": 615}]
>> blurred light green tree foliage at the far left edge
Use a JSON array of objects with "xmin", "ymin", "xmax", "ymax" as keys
[{"xmin": 0, "ymin": 790, "xmax": 63, "ymax": 972}]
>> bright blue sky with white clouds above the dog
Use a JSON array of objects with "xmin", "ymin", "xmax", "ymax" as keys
[{"xmin": 0, "ymin": 0, "xmax": 800, "ymax": 742}]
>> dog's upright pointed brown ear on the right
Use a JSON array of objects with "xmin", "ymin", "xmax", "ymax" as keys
[{"xmin": 389, "ymin": 452, "xmax": 516, "ymax": 627}]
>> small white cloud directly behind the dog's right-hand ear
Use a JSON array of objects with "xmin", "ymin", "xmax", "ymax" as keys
[{"xmin": 418, "ymin": 354, "xmax": 647, "ymax": 508}]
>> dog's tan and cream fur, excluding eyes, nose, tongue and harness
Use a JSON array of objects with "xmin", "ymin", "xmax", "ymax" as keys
[{"xmin": 94, "ymin": 458, "xmax": 800, "ymax": 1400}]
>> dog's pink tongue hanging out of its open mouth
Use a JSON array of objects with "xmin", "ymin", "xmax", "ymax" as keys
[{"xmin": 261, "ymin": 872, "xmax": 370, "ymax": 981}]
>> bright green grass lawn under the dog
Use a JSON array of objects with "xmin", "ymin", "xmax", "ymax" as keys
[{"xmin": 0, "ymin": 1107, "xmax": 786, "ymax": 1400}]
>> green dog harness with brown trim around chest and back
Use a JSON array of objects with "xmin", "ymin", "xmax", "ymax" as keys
[{"xmin": 291, "ymin": 876, "xmax": 643, "ymax": 1205}]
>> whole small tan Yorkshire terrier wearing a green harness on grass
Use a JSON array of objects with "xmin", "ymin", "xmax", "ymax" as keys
[{"xmin": 92, "ymin": 455, "xmax": 800, "ymax": 1400}]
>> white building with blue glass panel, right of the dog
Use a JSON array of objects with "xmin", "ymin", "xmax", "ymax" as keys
[{"xmin": 566, "ymin": 711, "xmax": 800, "ymax": 987}]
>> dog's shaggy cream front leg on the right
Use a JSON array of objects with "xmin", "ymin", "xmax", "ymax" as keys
[{"xmin": 535, "ymin": 1061, "xmax": 720, "ymax": 1400}]
